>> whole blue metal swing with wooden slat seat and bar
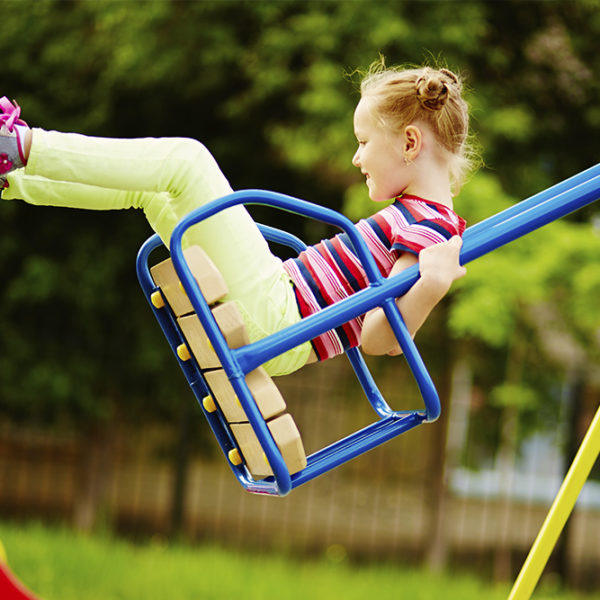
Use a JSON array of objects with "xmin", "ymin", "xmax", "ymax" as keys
[{"xmin": 136, "ymin": 165, "xmax": 600, "ymax": 496}]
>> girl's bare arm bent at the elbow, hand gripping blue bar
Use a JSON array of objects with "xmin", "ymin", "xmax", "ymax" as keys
[{"xmin": 361, "ymin": 236, "xmax": 467, "ymax": 355}]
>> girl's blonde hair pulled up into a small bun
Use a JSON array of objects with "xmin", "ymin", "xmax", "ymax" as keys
[{"xmin": 360, "ymin": 58, "xmax": 474, "ymax": 193}]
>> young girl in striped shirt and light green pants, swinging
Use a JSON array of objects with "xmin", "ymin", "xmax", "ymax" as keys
[{"xmin": 0, "ymin": 65, "xmax": 468, "ymax": 375}]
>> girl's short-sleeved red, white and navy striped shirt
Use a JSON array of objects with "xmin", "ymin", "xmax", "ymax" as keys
[{"xmin": 284, "ymin": 195, "xmax": 466, "ymax": 360}]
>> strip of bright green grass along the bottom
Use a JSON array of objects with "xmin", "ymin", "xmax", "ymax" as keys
[{"xmin": 0, "ymin": 522, "xmax": 583, "ymax": 600}]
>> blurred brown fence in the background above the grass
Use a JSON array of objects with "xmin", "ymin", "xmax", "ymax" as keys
[{"xmin": 0, "ymin": 360, "xmax": 600, "ymax": 589}]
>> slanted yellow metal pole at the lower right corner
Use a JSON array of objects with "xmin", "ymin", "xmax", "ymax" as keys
[{"xmin": 508, "ymin": 407, "xmax": 600, "ymax": 600}]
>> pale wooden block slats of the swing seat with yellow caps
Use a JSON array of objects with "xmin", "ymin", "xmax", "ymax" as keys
[{"xmin": 150, "ymin": 246, "xmax": 306, "ymax": 479}]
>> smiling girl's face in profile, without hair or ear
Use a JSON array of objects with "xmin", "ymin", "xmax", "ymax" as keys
[{"xmin": 352, "ymin": 96, "xmax": 409, "ymax": 202}]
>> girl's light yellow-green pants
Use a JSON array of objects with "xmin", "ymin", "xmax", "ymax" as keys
[{"xmin": 2, "ymin": 129, "xmax": 310, "ymax": 375}]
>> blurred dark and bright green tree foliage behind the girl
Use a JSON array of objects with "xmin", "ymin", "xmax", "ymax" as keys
[{"xmin": 0, "ymin": 0, "xmax": 600, "ymax": 440}]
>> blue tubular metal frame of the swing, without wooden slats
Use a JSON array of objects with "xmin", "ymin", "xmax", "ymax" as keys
[{"xmin": 136, "ymin": 164, "xmax": 600, "ymax": 496}]
